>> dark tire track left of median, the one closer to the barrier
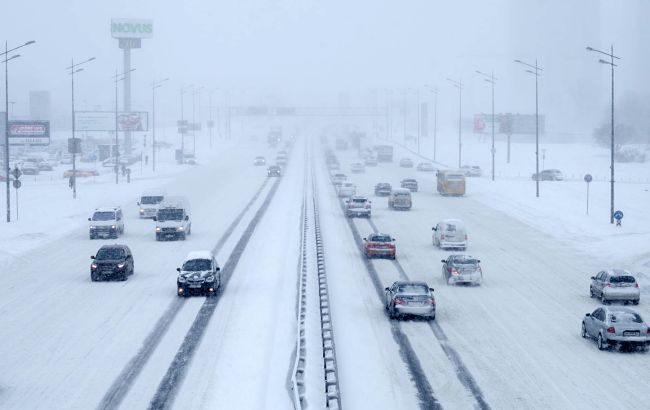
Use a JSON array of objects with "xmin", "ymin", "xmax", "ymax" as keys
[{"xmin": 149, "ymin": 178, "xmax": 281, "ymax": 410}]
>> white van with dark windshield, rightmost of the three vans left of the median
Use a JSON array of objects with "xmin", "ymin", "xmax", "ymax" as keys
[{"xmin": 153, "ymin": 196, "xmax": 192, "ymax": 241}]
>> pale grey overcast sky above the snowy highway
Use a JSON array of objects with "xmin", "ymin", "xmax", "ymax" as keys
[{"xmin": 0, "ymin": 0, "xmax": 650, "ymax": 132}]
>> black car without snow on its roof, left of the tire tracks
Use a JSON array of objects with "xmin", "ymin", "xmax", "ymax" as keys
[{"xmin": 90, "ymin": 245, "xmax": 135, "ymax": 282}]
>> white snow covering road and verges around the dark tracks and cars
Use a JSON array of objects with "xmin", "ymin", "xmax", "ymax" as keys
[{"xmin": 0, "ymin": 135, "xmax": 650, "ymax": 409}]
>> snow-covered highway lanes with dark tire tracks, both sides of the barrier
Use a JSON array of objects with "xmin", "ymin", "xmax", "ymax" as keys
[{"xmin": 0, "ymin": 138, "xmax": 650, "ymax": 409}]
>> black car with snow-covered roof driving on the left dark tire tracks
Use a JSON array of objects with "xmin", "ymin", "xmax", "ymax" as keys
[{"xmin": 176, "ymin": 251, "xmax": 221, "ymax": 296}]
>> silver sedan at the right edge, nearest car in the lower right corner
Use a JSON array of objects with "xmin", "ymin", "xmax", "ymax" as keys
[{"xmin": 582, "ymin": 306, "xmax": 650, "ymax": 350}]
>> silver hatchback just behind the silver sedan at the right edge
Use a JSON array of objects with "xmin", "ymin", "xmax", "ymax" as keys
[{"xmin": 589, "ymin": 269, "xmax": 641, "ymax": 305}]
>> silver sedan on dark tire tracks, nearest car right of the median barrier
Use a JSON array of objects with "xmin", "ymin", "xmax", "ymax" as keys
[{"xmin": 384, "ymin": 281, "xmax": 436, "ymax": 320}]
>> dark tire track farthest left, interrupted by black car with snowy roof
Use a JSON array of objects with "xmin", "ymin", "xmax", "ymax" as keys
[{"xmin": 97, "ymin": 178, "xmax": 269, "ymax": 410}]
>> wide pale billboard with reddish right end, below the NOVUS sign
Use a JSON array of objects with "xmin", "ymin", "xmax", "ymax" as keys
[{"xmin": 74, "ymin": 111, "xmax": 149, "ymax": 131}]
